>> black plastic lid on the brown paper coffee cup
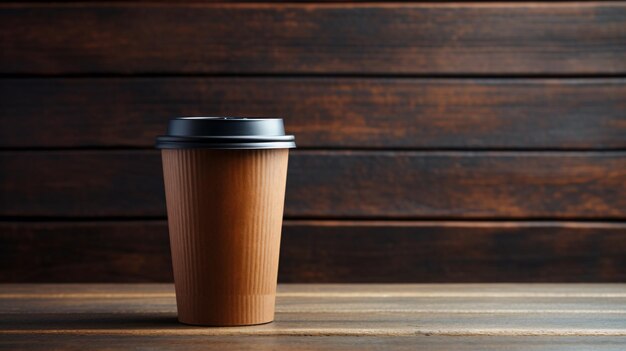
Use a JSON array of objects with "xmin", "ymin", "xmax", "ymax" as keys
[{"xmin": 156, "ymin": 117, "xmax": 296, "ymax": 149}]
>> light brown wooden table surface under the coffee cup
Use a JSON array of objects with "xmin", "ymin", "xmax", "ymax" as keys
[{"xmin": 0, "ymin": 284, "xmax": 626, "ymax": 350}]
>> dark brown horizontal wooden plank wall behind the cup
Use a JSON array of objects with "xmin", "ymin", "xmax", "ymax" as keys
[{"xmin": 0, "ymin": 1, "xmax": 626, "ymax": 282}]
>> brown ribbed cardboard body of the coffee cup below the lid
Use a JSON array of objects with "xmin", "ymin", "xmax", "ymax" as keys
[{"xmin": 162, "ymin": 149, "xmax": 289, "ymax": 326}]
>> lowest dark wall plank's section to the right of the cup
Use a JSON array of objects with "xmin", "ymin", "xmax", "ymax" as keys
[{"xmin": 280, "ymin": 222, "xmax": 626, "ymax": 283}]
